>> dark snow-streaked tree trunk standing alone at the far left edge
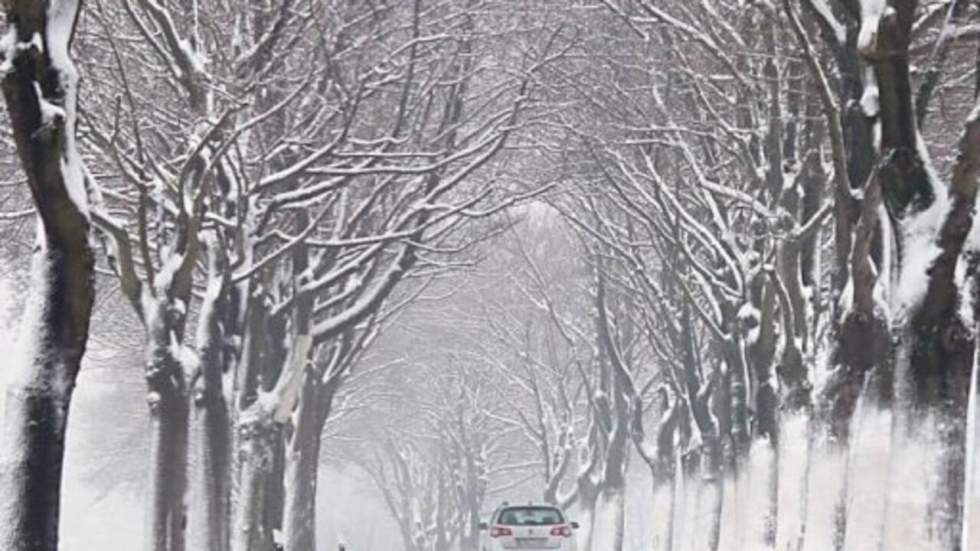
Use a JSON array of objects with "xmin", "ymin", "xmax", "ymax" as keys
[{"xmin": 0, "ymin": 0, "xmax": 95, "ymax": 551}]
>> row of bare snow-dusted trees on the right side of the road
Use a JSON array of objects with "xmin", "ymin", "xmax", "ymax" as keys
[{"xmin": 346, "ymin": 0, "xmax": 980, "ymax": 550}]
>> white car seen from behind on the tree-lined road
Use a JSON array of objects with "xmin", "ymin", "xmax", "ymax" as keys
[{"xmin": 480, "ymin": 503, "xmax": 578, "ymax": 551}]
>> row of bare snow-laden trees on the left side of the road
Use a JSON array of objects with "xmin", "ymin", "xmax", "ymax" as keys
[{"xmin": 0, "ymin": 0, "xmax": 561, "ymax": 551}]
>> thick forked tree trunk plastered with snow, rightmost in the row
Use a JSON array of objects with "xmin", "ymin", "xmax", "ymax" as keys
[{"xmin": 862, "ymin": 3, "xmax": 980, "ymax": 551}]
